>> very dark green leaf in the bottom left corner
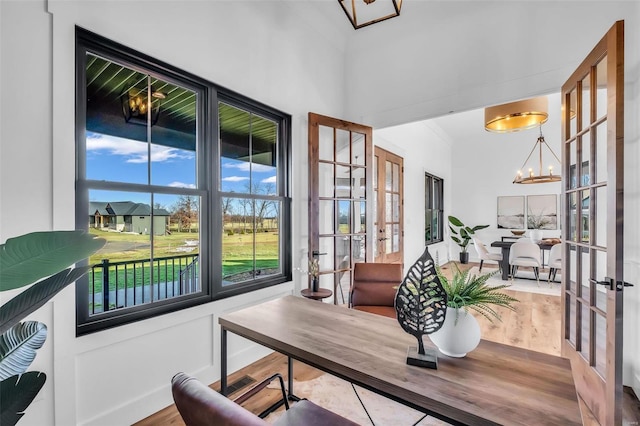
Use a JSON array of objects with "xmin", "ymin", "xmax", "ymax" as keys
[{"xmin": 0, "ymin": 371, "xmax": 47, "ymax": 426}]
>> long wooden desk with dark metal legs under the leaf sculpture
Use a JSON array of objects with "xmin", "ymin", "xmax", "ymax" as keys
[{"xmin": 219, "ymin": 296, "xmax": 582, "ymax": 426}]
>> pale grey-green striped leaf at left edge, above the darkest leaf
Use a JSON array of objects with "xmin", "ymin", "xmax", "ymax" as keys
[{"xmin": 0, "ymin": 321, "xmax": 47, "ymax": 380}]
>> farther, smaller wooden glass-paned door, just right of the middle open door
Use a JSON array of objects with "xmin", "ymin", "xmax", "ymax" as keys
[{"xmin": 373, "ymin": 147, "xmax": 404, "ymax": 263}]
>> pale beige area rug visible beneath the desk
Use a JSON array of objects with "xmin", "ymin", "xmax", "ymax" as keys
[{"xmin": 265, "ymin": 374, "xmax": 449, "ymax": 426}]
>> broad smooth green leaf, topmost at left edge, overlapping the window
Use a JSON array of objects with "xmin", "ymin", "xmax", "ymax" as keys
[{"xmin": 0, "ymin": 231, "xmax": 106, "ymax": 291}]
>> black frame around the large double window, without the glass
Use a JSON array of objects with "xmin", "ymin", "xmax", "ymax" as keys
[{"xmin": 75, "ymin": 27, "xmax": 292, "ymax": 336}]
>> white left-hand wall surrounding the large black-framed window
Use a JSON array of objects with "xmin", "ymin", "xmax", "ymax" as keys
[{"xmin": 0, "ymin": 0, "xmax": 345, "ymax": 425}]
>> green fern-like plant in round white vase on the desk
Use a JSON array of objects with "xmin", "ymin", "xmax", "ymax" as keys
[{"xmin": 429, "ymin": 262, "xmax": 519, "ymax": 358}]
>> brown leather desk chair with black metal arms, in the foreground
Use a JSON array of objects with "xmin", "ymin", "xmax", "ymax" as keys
[{"xmin": 171, "ymin": 373, "xmax": 357, "ymax": 426}]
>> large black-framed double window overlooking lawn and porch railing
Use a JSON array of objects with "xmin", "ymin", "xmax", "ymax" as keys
[{"xmin": 76, "ymin": 29, "xmax": 291, "ymax": 334}]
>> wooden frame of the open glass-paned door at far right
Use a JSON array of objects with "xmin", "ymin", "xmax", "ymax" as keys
[{"xmin": 561, "ymin": 21, "xmax": 624, "ymax": 425}]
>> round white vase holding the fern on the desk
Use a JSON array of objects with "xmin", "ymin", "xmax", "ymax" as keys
[{"xmin": 429, "ymin": 307, "xmax": 480, "ymax": 358}]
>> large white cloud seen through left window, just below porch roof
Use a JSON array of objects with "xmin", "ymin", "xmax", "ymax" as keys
[{"xmin": 87, "ymin": 133, "xmax": 193, "ymax": 163}]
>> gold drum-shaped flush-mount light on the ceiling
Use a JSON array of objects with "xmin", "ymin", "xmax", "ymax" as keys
[{"xmin": 484, "ymin": 96, "xmax": 549, "ymax": 133}]
